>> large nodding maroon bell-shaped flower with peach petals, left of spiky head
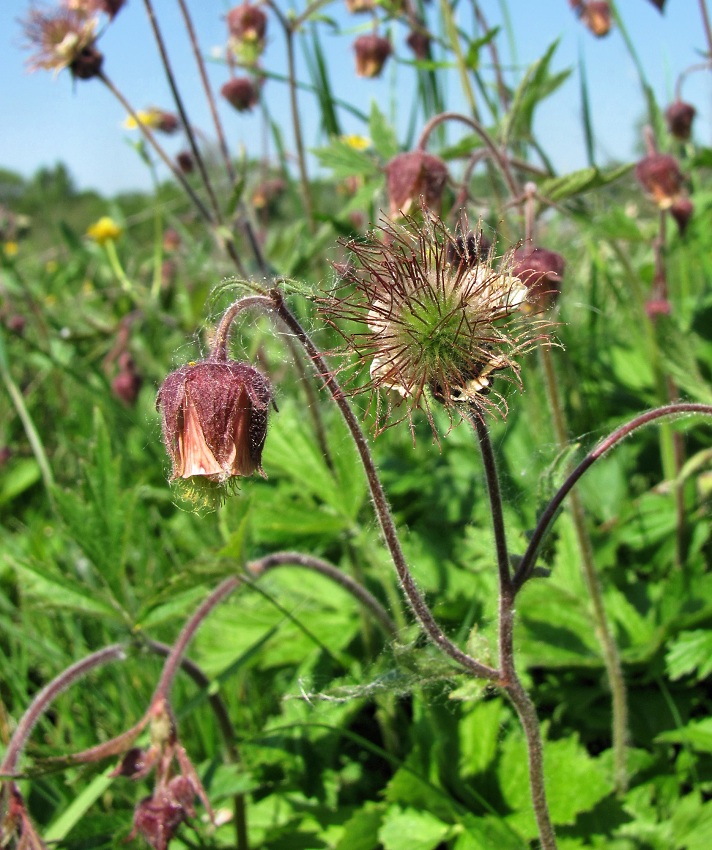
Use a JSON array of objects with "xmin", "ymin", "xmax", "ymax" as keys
[{"xmin": 156, "ymin": 360, "xmax": 272, "ymax": 483}]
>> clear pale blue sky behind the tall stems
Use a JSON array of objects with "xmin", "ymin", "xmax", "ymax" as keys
[{"xmin": 0, "ymin": 0, "xmax": 712, "ymax": 194}]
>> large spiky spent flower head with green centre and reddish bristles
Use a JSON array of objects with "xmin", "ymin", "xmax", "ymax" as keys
[{"xmin": 325, "ymin": 210, "xmax": 545, "ymax": 432}]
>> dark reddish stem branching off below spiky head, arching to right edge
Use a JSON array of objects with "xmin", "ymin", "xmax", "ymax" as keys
[{"xmin": 514, "ymin": 402, "xmax": 712, "ymax": 591}]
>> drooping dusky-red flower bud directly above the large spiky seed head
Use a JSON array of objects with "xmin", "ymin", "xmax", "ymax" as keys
[{"xmin": 386, "ymin": 150, "xmax": 448, "ymax": 215}]
